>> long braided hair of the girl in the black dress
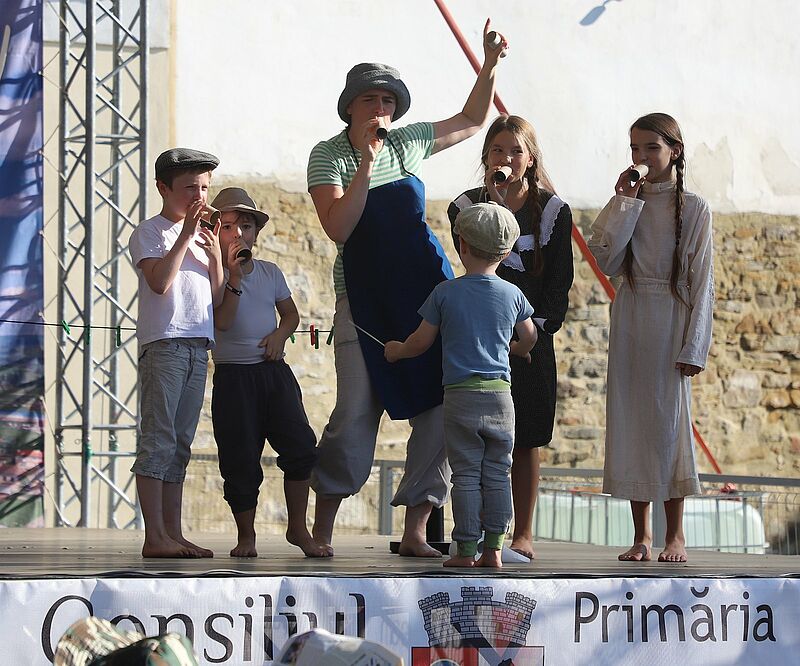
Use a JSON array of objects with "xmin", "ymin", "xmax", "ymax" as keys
[{"xmin": 481, "ymin": 116, "xmax": 552, "ymax": 275}]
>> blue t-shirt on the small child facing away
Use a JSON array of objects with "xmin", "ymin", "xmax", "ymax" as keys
[{"xmin": 419, "ymin": 275, "xmax": 533, "ymax": 386}]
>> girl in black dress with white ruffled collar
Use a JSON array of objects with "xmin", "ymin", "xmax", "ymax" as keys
[{"xmin": 447, "ymin": 116, "xmax": 573, "ymax": 559}]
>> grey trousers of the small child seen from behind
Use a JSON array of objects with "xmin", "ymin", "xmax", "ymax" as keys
[{"xmin": 444, "ymin": 389, "xmax": 514, "ymax": 543}]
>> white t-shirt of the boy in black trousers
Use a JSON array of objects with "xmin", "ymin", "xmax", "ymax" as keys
[{"xmin": 211, "ymin": 259, "xmax": 292, "ymax": 365}]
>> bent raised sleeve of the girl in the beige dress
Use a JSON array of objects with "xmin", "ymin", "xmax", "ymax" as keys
[{"xmin": 588, "ymin": 195, "xmax": 644, "ymax": 276}]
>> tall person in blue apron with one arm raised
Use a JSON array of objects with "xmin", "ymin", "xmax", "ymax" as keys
[{"xmin": 308, "ymin": 21, "xmax": 508, "ymax": 557}]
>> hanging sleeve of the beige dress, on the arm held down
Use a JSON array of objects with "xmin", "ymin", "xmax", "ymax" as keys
[{"xmin": 678, "ymin": 203, "xmax": 714, "ymax": 368}]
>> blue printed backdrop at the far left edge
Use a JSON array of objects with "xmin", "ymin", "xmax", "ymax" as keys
[{"xmin": 0, "ymin": 0, "xmax": 44, "ymax": 527}]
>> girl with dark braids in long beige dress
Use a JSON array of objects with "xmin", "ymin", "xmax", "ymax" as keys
[{"xmin": 589, "ymin": 113, "xmax": 714, "ymax": 562}]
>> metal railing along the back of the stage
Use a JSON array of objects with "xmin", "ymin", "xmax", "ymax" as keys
[{"xmin": 184, "ymin": 455, "xmax": 800, "ymax": 555}]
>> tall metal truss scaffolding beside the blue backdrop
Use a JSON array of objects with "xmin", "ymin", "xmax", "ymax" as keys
[{"xmin": 53, "ymin": 0, "xmax": 148, "ymax": 527}]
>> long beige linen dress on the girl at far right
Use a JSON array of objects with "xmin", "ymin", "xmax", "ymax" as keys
[{"xmin": 589, "ymin": 181, "xmax": 714, "ymax": 501}]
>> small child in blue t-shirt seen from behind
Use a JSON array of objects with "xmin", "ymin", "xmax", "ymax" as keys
[{"xmin": 384, "ymin": 203, "xmax": 536, "ymax": 567}]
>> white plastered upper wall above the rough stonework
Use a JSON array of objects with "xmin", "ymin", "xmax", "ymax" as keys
[{"xmin": 170, "ymin": 0, "xmax": 800, "ymax": 214}]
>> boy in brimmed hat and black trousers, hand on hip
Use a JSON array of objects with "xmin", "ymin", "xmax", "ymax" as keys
[{"xmin": 211, "ymin": 187, "xmax": 327, "ymax": 557}]
